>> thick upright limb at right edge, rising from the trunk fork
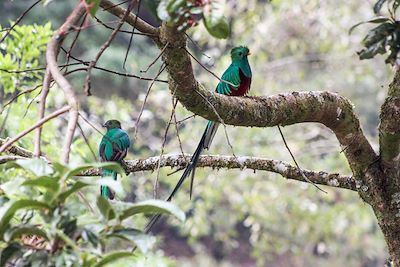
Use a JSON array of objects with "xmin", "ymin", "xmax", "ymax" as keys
[{"xmin": 379, "ymin": 69, "xmax": 400, "ymax": 165}]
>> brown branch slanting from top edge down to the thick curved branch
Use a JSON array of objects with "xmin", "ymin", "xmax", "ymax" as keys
[{"xmin": 100, "ymin": 0, "xmax": 159, "ymax": 39}]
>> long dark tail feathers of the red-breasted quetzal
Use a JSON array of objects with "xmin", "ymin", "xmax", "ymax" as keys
[{"xmin": 145, "ymin": 121, "xmax": 219, "ymax": 233}]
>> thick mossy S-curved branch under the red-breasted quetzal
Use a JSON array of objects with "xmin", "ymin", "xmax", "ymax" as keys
[{"xmin": 159, "ymin": 24, "xmax": 377, "ymax": 184}]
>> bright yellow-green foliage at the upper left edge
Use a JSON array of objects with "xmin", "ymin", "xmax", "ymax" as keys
[{"xmin": 0, "ymin": 22, "xmax": 52, "ymax": 93}]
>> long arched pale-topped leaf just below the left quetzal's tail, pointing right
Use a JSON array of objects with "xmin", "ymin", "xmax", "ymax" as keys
[{"xmin": 120, "ymin": 199, "xmax": 185, "ymax": 221}]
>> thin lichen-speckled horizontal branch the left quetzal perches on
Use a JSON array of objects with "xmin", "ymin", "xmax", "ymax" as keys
[{"xmin": 81, "ymin": 155, "xmax": 357, "ymax": 191}]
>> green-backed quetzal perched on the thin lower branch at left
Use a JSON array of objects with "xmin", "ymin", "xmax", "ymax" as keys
[{"xmin": 99, "ymin": 120, "xmax": 131, "ymax": 199}]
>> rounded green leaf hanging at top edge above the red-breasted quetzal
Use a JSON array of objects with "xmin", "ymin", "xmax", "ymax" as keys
[{"xmin": 203, "ymin": 0, "xmax": 230, "ymax": 39}]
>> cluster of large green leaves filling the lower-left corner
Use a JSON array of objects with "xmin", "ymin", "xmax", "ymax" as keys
[{"xmin": 0, "ymin": 159, "xmax": 185, "ymax": 267}]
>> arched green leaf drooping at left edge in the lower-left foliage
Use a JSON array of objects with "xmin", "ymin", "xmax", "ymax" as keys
[{"xmin": 0, "ymin": 199, "xmax": 51, "ymax": 237}]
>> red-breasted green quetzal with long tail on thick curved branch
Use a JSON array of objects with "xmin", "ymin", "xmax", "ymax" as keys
[{"xmin": 146, "ymin": 46, "xmax": 252, "ymax": 231}]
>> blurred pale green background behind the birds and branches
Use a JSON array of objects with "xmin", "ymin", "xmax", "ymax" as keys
[{"xmin": 0, "ymin": 0, "xmax": 393, "ymax": 267}]
